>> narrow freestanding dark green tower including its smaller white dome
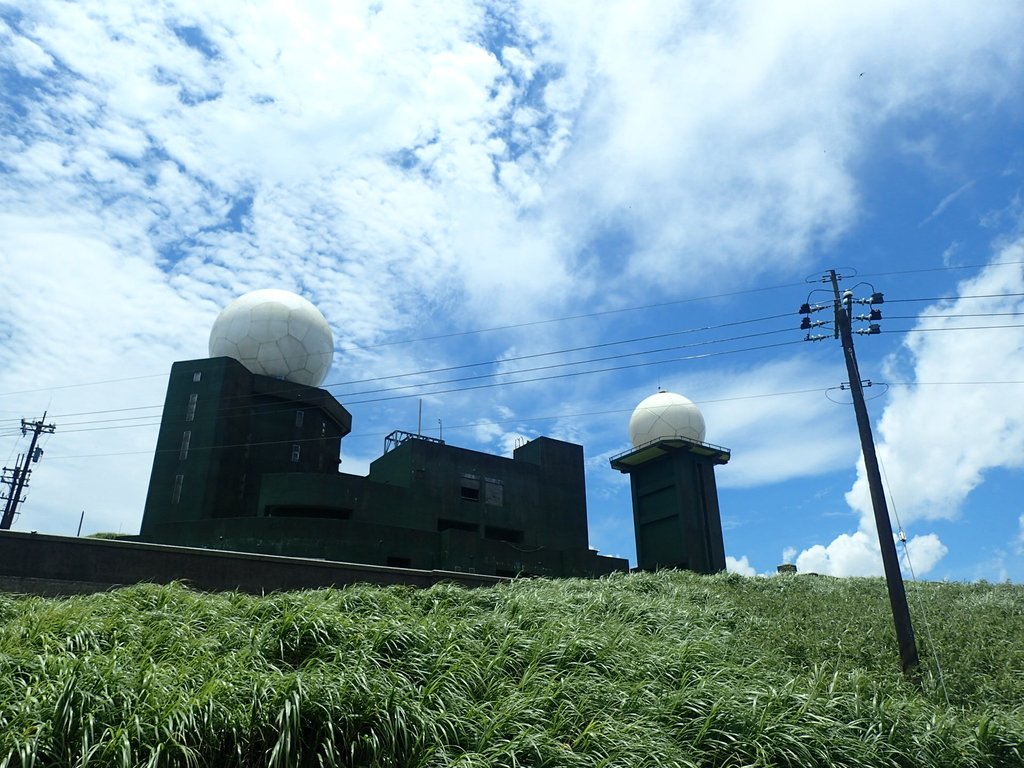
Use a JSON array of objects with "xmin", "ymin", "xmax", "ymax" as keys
[{"xmin": 611, "ymin": 391, "xmax": 730, "ymax": 573}]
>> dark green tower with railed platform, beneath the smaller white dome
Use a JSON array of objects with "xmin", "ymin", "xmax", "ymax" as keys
[{"xmin": 611, "ymin": 437, "xmax": 730, "ymax": 573}]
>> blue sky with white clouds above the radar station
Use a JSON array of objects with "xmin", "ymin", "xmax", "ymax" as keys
[{"xmin": 6, "ymin": 0, "xmax": 1024, "ymax": 582}]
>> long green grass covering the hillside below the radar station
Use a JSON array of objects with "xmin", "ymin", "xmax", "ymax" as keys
[{"xmin": 0, "ymin": 572, "xmax": 1024, "ymax": 768}]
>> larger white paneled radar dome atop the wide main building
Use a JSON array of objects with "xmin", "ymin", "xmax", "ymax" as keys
[{"xmin": 210, "ymin": 288, "xmax": 334, "ymax": 387}]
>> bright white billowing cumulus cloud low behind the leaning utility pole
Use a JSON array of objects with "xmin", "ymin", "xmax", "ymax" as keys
[{"xmin": 797, "ymin": 246, "xmax": 1024, "ymax": 575}]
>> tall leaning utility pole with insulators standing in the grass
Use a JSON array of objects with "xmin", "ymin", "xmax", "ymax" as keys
[{"xmin": 800, "ymin": 269, "xmax": 919, "ymax": 677}]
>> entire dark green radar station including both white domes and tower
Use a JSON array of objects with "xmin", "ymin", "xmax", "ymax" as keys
[{"xmin": 137, "ymin": 290, "xmax": 729, "ymax": 577}]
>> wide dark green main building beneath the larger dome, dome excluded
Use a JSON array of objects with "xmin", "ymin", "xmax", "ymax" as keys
[{"xmin": 139, "ymin": 357, "xmax": 628, "ymax": 577}]
